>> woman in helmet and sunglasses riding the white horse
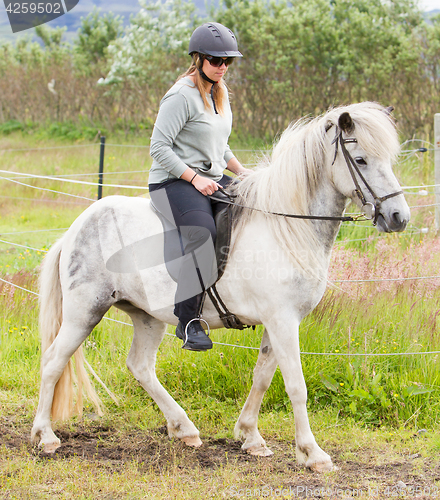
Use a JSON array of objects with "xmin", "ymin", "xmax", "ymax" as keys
[{"xmin": 149, "ymin": 23, "xmax": 249, "ymax": 351}]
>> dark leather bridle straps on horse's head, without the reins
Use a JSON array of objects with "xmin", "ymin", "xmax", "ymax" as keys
[{"xmin": 332, "ymin": 128, "xmax": 403, "ymax": 226}]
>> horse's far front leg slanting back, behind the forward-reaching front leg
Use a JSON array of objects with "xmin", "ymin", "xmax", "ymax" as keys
[{"xmin": 235, "ymin": 330, "xmax": 277, "ymax": 457}]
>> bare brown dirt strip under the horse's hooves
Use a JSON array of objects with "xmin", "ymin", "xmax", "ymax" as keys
[{"xmin": 0, "ymin": 419, "xmax": 440, "ymax": 499}]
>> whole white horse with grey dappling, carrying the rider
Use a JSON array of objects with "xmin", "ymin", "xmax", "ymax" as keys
[{"xmin": 32, "ymin": 103, "xmax": 410, "ymax": 470}]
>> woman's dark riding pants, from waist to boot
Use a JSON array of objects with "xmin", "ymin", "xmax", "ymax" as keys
[{"xmin": 149, "ymin": 175, "xmax": 233, "ymax": 325}]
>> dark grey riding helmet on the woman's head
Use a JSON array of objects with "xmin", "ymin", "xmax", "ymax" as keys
[{"xmin": 188, "ymin": 23, "xmax": 243, "ymax": 57}]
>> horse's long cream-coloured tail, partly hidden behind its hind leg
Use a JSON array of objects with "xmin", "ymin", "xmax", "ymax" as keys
[{"xmin": 39, "ymin": 239, "xmax": 102, "ymax": 420}]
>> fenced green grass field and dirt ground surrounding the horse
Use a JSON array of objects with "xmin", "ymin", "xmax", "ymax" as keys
[{"xmin": 0, "ymin": 134, "xmax": 440, "ymax": 499}]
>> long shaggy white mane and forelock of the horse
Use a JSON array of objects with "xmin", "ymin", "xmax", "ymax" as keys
[{"xmin": 234, "ymin": 102, "xmax": 399, "ymax": 274}]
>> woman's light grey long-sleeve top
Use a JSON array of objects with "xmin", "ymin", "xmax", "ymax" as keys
[{"xmin": 148, "ymin": 77, "xmax": 234, "ymax": 184}]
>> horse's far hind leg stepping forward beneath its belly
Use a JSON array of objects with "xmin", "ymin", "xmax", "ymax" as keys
[{"xmin": 117, "ymin": 304, "xmax": 202, "ymax": 447}]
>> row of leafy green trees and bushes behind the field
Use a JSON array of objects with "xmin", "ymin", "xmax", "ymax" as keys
[{"xmin": 0, "ymin": 0, "xmax": 440, "ymax": 140}]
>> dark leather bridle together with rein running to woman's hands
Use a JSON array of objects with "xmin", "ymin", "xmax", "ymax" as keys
[{"xmin": 214, "ymin": 127, "xmax": 403, "ymax": 225}]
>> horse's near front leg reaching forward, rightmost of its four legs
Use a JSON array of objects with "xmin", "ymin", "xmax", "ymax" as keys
[{"xmin": 265, "ymin": 312, "xmax": 334, "ymax": 472}]
